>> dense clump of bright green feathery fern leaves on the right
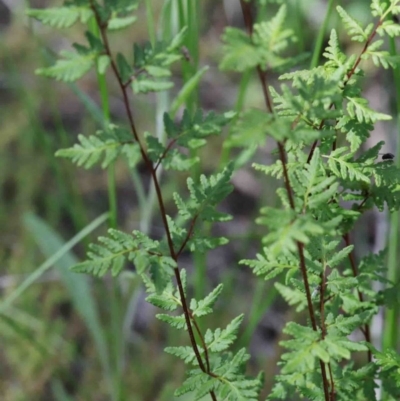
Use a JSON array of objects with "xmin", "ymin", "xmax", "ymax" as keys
[{"xmin": 225, "ymin": 0, "xmax": 400, "ymax": 400}]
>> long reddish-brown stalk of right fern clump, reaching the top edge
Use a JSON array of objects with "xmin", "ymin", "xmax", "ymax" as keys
[{"xmin": 240, "ymin": 0, "xmax": 330, "ymax": 401}]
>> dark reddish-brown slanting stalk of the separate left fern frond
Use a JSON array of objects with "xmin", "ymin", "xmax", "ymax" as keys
[{"xmin": 91, "ymin": 1, "xmax": 217, "ymax": 401}]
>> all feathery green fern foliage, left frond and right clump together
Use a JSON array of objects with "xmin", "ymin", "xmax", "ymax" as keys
[{"xmin": 29, "ymin": 0, "xmax": 400, "ymax": 401}]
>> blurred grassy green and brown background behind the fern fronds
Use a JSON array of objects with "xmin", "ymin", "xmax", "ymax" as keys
[{"xmin": 0, "ymin": 0, "xmax": 397, "ymax": 401}]
